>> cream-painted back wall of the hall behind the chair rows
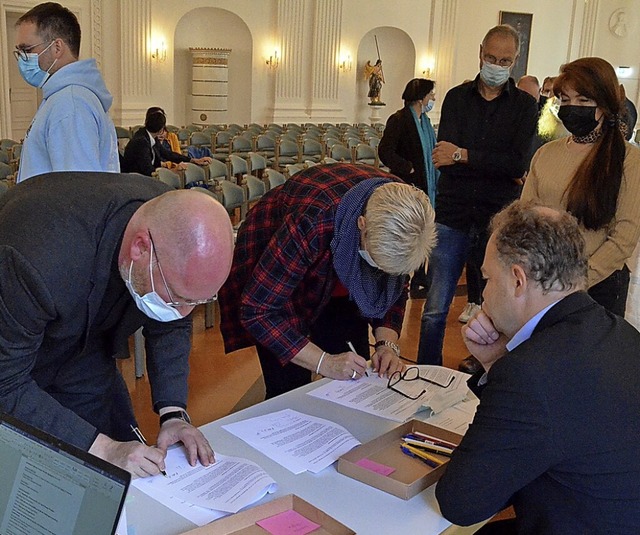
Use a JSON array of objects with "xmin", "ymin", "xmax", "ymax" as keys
[{"xmin": 0, "ymin": 0, "xmax": 640, "ymax": 137}]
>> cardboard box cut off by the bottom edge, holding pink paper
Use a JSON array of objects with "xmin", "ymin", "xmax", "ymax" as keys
[{"xmin": 180, "ymin": 494, "xmax": 355, "ymax": 535}]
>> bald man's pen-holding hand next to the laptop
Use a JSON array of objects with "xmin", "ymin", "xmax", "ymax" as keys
[{"xmin": 89, "ymin": 433, "xmax": 166, "ymax": 477}]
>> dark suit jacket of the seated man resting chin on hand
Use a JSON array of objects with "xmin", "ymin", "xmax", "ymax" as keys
[{"xmin": 436, "ymin": 292, "xmax": 640, "ymax": 535}]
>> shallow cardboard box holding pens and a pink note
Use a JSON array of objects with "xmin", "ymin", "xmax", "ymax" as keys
[{"xmin": 338, "ymin": 420, "xmax": 462, "ymax": 500}]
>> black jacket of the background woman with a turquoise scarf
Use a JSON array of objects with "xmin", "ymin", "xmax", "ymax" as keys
[{"xmin": 378, "ymin": 107, "xmax": 427, "ymax": 193}]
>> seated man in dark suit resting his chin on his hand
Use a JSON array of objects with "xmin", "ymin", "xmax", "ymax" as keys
[{"xmin": 436, "ymin": 201, "xmax": 640, "ymax": 535}]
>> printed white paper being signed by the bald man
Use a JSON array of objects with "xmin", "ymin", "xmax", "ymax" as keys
[{"xmin": 133, "ymin": 448, "xmax": 277, "ymax": 526}]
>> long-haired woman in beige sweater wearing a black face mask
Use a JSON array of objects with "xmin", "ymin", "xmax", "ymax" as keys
[{"xmin": 522, "ymin": 58, "xmax": 640, "ymax": 316}]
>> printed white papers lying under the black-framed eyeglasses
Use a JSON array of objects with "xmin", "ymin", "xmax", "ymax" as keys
[{"xmin": 308, "ymin": 366, "xmax": 468, "ymax": 422}]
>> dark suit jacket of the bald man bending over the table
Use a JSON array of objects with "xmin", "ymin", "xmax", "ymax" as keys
[{"xmin": 0, "ymin": 172, "xmax": 191, "ymax": 449}]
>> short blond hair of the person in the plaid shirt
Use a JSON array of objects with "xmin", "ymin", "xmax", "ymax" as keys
[{"xmin": 364, "ymin": 182, "xmax": 436, "ymax": 275}]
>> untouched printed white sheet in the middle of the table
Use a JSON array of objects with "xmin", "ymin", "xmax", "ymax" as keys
[{"xmin": 222, "ymin": 409, "xmax": 360, "ymax": 474}]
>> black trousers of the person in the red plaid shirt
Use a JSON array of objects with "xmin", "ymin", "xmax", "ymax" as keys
[{"xmin": 256, "ymin": 297, "xmax": 370, "ymax": 399}]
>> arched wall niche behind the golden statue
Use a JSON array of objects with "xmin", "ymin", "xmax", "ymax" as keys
[{"xmin": 354, "ymin": 26, "xmax": 416, "ymax": 122}]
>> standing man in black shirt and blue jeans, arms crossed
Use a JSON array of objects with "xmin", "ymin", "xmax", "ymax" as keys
[{"xmin": 418, "ymin": 25, "xmax": 537, "ymax": 371}]
